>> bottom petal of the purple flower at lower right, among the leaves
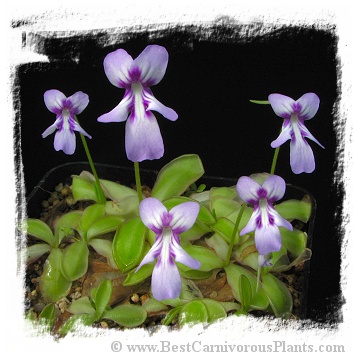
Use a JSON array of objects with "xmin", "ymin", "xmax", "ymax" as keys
[{"xmin": 255, "ymin": 224, "xmax": 281, "ymax": 255}]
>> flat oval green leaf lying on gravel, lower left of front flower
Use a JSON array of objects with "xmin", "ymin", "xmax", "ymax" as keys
[{"xmin": 102, "ymin": 305, "xmax": 147, "ymax": 327}]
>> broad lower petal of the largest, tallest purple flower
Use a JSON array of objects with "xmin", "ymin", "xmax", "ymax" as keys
[{"xmin": 125, "ymin": 111, "xmax": 164, "ymax": 162}]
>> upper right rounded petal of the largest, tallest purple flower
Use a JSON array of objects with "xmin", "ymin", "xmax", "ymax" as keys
[{"xmin": 130, "ymin": 45, "xmax": 169, "ymax": 87}]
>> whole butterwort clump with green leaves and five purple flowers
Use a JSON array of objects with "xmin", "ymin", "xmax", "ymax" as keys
[{"xmin": 21, "ymin": 45, "xmax": 320, "ymax": 334}]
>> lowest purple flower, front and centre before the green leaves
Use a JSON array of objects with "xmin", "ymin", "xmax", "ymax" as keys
[{"xmin": 136, "ymin": 197, "xmax": 201, "ymax": 300}]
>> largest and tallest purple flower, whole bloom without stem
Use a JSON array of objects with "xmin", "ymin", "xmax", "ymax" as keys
[{"xmin": 97, "ymin": 45, "xmax": 178, "ymax": 162}]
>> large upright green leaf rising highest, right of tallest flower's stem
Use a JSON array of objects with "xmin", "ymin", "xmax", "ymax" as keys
[{"xmin": 152, "ymin": 154, "xmax": 205, "ymax": 201}]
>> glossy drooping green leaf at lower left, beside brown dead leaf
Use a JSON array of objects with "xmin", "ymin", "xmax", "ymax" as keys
[{"xmin": 39, "ymin": 248, "xmax": 71, "ymax": 302}]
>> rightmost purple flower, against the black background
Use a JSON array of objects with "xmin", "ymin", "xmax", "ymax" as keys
[{"xmin": 268, "ymin": 93, "xmax": 324, "ymax": 174}]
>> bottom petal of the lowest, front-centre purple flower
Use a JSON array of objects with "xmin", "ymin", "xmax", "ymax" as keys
[{"xmin": 152, "ymin": 259, "xmax": 181, "ymax": 301}]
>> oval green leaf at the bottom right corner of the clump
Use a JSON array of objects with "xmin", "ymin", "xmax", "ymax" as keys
[{"xmin": 262, "ymin": 274, "xmax": 293, "ymax": 318}]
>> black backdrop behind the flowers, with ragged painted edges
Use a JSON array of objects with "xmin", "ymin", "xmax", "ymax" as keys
[{"xmin": 13, "ymin": 20, "xmax": 343, "ymax": 324}]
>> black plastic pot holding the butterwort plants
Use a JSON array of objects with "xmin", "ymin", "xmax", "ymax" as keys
[{"xmin": 27, "ymin": 162, "xmax": 316, "ymax": 319}]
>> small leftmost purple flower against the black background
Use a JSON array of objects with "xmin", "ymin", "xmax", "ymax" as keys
[{"xmin": 42, "ymin": 89, "xmax": 91, "ymax": 155}]
